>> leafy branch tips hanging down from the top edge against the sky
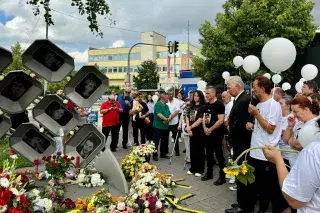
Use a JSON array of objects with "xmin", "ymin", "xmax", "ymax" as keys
[{"xmin": 27, "ymin": 0, "xmax": 115, "ymax": 38}]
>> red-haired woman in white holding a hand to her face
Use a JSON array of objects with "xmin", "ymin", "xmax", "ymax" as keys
[{"xmin": 282, "ymin": 95, "xmax": 320, "ymax": 166}]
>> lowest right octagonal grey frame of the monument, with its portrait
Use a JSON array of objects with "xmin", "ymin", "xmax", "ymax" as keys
[{"xmin": 65, "ymin": 124, "xmax": 107, "ymax": 168}]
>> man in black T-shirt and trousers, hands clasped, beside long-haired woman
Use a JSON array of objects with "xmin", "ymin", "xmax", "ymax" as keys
[{"xmin": 201, "ymin": 87, "xmax": 226, "ymax": 185}]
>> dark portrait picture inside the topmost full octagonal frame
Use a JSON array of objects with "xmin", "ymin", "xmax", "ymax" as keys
[{"xmin": 33, "ymin": 45, "xmax": 65, "ymax": 72}]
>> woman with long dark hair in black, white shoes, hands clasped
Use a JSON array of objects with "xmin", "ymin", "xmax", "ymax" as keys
[{"xmin": 186, "ymin": 90, "xmax": 205, "ymax": 177}]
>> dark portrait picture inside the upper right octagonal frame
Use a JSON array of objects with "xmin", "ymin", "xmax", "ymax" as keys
[{"xmin": 75, "ymin": 73, "xmax": 102, "ymax": 99}]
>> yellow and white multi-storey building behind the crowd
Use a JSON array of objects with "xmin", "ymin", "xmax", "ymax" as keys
[{"xmin": 88, "ymin": 32, "xmax": 199, "ymax": 87}]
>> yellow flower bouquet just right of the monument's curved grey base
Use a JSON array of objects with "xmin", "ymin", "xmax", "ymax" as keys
[{"xmin": 121, "ymin": 153, "xmax": 145, "ymax": 181}]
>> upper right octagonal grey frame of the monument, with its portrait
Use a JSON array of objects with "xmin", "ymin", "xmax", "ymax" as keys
[{"xmin": 64, "ymin": 66, "xmax": 109, "ymax": 108}]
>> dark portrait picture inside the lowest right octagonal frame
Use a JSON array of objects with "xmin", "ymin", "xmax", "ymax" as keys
[{"xmin": 76, "ymin": 132, "xmax": 102, "ymax": 159}]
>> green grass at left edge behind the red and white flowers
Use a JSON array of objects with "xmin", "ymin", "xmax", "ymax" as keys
[{"xmin": 0, "ymin": 137, "xmax": 33, "ymax": 169}]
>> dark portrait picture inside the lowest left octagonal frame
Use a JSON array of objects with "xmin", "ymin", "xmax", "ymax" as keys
[{"xmin": 22, "ymin": 129, "xmax": 51, "ymax": 154}]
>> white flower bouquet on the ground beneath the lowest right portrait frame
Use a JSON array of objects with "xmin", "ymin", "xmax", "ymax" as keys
[{"xmin": 77, "ymin": 169, "xmax": 105, "ymax": 187}]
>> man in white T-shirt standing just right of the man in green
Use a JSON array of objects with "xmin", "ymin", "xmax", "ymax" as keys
[{"xmin": 167, "ymin": 90, "xmax": 180, "ymax": 156}]
